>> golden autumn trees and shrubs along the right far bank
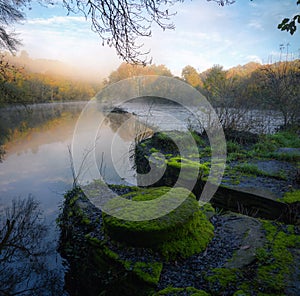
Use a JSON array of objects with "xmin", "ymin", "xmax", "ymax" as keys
[{"xmin": 104, "ymin": 59, "xmax": 300, "ymax": 130}]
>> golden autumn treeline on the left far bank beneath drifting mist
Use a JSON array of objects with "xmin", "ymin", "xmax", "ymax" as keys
[{"xmin": 0, "ymin": 55, "xmax": 101, "ymax": 107}]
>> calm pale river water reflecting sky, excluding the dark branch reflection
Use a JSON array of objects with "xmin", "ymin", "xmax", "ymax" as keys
[{"xmin": 0, "ymin": 102, "xmax": 284, "ymax": 295}]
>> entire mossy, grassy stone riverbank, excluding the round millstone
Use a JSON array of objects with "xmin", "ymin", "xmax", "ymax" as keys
[{"xmin": 59, "ymin": 128, "xmax": 300, "ymax": 296}]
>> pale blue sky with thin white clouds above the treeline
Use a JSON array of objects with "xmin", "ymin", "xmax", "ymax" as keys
[{"xmin": 15, "ymin": 0, "xmax": 300, "ymax": 78}]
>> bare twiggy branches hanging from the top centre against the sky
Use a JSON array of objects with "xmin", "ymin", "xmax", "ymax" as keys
[{"xmin": 63, "ymin": 0, "xmax": 182, "ymax": 65}]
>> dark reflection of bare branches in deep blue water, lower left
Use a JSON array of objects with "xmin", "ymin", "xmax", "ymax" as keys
[{"xmin": 0, "ymin": 196, "xmax": 63, "ymax": 295}]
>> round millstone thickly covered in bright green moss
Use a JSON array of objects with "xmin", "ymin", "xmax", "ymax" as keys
[{"xmin": 102, "ymin": 187, "xmax": 213, "ymax": 259}]
